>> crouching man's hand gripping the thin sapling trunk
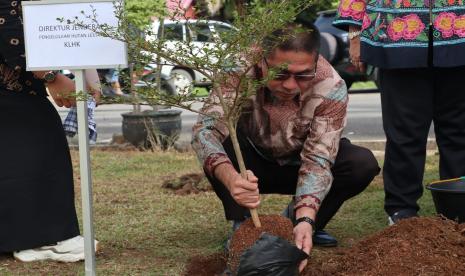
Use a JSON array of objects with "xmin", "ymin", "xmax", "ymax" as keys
[{"xmin": 215, "ymin": 163, "xmax": 260, "ymax": 209}]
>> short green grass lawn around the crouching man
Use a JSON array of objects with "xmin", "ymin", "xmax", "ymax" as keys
[{"xmin": 0, "ymin": 150, "xmax": 438, "ymax": 275}]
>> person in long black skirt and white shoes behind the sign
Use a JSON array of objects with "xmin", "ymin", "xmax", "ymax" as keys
[{"xmin": 0, "ymin": 0, "xmax": 96, "ymax": 262}]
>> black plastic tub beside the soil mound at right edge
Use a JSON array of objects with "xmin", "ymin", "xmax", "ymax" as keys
[{"xmin": 426, "ymin": 177, "xmax": 465, "ymax": 223}]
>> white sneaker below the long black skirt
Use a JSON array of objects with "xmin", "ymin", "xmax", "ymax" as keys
[{"xmin": 13, "ymin": 236, "xmax": 98, "ymax": 262}]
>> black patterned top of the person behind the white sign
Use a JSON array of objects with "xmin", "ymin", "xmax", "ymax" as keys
[{"xmin": 0, "ymin": 0, "xmax": 47, "ymax": 96}]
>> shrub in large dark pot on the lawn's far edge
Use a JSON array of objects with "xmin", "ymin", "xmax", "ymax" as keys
[{"xmin": 117, "ymin": 1, "xmax": 182, "ymax": 149}]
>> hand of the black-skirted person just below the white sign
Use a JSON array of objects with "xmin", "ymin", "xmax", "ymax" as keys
[{"xmin": 47, "ymin": 74, "xmax": 76, "ymax": 108}]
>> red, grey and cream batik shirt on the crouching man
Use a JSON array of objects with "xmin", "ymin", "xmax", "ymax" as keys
[{"xmin": 192, "ymin": 56, "xmax": 348, "ymax": 210}]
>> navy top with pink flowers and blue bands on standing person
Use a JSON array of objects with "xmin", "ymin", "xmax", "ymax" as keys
[{"xmin": 333, "ymin": 0, "xmax": 465, "ymax": 68}]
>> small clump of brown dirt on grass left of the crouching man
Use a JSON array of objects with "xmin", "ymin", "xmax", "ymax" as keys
[{"xmin": 162, "ymin": 173, "xmax": 212, "ymax": 195}]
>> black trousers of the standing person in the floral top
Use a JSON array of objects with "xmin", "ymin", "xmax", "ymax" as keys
[{"xmin": 379, "ymin": 66, "xmax": 465, "ymax": 215}]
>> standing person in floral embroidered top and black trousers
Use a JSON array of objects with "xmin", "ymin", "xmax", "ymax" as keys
[{"xmin": 333, "ymin": 0, "xmax": 465, "ymax": 224}]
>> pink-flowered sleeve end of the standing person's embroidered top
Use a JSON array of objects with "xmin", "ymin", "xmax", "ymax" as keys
[{"xmin": 333, "ymin": 0, "xmax": 366, "ymax": 31}]
